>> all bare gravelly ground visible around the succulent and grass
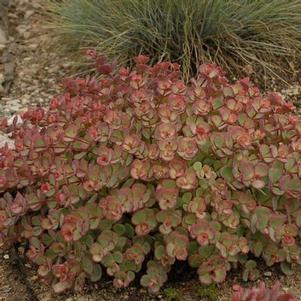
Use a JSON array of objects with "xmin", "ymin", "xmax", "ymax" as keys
[{"xmin": 0, "ymin": 0, "xmax": 301, "ymax": 301}]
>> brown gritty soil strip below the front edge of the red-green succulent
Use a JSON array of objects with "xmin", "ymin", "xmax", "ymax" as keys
[{"xmin": 0, "ymin": 250, "xmax": 301, "ymax": 301}]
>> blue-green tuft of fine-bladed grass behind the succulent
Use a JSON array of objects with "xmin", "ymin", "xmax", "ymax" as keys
[{"xmin": 48, "ymin": 0, "xmax": 301, "ymax": 80}]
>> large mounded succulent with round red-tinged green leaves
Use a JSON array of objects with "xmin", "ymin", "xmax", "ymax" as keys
[{"xmin": 0, "ymin": 51, "xmax": 301, "ymax": 293}]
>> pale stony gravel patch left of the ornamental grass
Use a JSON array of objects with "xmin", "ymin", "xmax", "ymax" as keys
[{"xmin": 0, "ymin": 0, "xmax": 71, "ymax": 116}]
